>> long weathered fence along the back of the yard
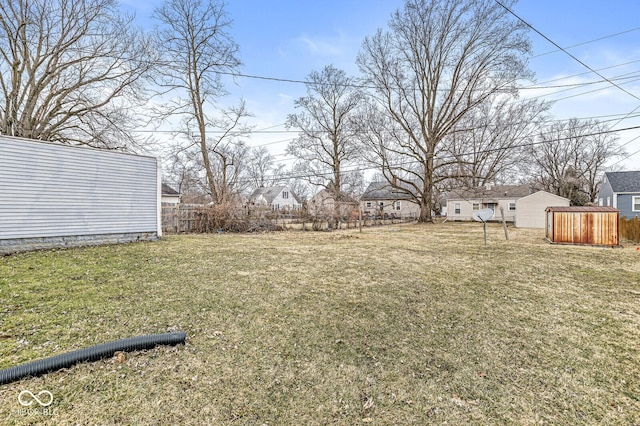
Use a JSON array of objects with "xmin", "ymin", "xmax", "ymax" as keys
[{"xmin": 162, "ymin": 204, "xmax": 415, "ymax": 234}]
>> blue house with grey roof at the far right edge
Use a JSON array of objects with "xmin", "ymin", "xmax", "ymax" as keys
[{"xmin": 598, "ymin": 171, "xmax": 640, "ymax": 219}]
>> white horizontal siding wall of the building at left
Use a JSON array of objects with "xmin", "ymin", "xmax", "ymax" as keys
[{"xmin": 0, "ymin": 137, "xmax": 159, "ymax": 240}]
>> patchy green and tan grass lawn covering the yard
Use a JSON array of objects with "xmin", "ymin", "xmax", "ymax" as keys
[{"xmin": 0, "ymin": 223, "xmax": 640, "ymax": 425}]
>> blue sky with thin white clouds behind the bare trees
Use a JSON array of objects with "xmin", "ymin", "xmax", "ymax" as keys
[{"xmin": 123, "ymin": 0, "xmax": 640, "ymax": 169}]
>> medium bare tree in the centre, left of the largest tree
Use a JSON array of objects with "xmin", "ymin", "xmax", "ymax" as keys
[{"xmin": 286, "ymin": 66, "xmax": 363, "ymax": 226}]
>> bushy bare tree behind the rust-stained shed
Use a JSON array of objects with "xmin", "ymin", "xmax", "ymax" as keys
[{"xmin": 526, "ymin": 118, "xmax": 624, "ymax": 205}]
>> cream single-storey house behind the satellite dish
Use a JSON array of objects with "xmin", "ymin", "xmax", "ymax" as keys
[{"xmin": 447, "ymin": 185, "xmax": 531, "ymax": 222}]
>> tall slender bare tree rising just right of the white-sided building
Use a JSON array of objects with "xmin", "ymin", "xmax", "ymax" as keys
[{"xmin": 154, "ymin": 0, "xmax": 248, "ymax": 203}]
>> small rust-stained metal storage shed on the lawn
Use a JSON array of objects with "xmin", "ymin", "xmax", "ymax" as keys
[{"xmin": 546, "ymin": 206, "xmax": 619, "ymax": 247}]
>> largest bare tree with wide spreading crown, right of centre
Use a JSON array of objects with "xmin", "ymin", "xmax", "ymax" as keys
[{"xmin": 357, "ymin": 0, "xmax": 530, "ymax": 222}]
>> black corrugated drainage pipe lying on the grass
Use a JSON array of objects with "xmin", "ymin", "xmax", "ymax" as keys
[{"xmin": 0, "ymin": 331, "xmax": 187, "ymax": 385}]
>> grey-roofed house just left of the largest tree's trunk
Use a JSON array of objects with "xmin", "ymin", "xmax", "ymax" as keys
[{"xmin": 360, "ymin": 182, "xmax": 420, "ymax": 218}]
